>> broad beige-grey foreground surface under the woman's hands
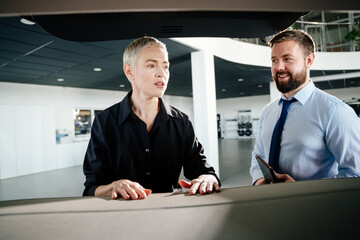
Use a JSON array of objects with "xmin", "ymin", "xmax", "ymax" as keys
[{"xmin": 0, "ymin": 178, "xmax": 360, "ymax": 239}]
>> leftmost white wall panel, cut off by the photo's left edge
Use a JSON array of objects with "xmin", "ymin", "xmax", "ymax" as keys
[{"xmin": 0, "ymin": 105, "xmax": 17, "ymax": 179}]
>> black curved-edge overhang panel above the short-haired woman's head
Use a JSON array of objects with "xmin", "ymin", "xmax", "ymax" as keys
[{"xmin": 28, "ymin": 11, "xmax": 306, "ymax": 42}]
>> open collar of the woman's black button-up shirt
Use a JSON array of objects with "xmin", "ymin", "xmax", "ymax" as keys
[{"xmin": 118, "ymin": 91, "xmax": 175, "ymax": 125}]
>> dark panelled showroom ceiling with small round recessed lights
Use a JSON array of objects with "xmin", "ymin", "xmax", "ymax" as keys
[{"xmin": 0, "ymin": 14, "xmax": 360, "ymax": 99}]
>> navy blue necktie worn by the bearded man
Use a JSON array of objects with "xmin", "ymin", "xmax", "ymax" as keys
[{"xmin": 269, "ymin": 98, "xmax": 296, "ymax": 172}]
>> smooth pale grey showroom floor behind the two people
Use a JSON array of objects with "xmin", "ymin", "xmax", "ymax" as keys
[{"xmin": 0, "ymin": 139, "xmax": 254, "ymax": 201}]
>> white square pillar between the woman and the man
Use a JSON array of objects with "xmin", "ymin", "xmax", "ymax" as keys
[{"xmin": 191, "ymin": 51, "xmax": 219, "ymax": 176}]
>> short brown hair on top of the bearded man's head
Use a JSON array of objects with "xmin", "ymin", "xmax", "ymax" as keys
[{"xmin": 268, "ymin": 29, "xmax": 315, "ymax": 57}]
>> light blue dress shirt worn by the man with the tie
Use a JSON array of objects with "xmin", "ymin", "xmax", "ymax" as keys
[{"xmin": 250, "ymin": 81, "xmax": 360, "ymax": 183}]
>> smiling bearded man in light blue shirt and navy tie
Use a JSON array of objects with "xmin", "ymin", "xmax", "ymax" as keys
[{"xmin": 250, "ymin": 30, "xmax": 360, "ymax": 185}]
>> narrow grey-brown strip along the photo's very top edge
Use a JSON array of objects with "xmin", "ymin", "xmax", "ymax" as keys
[{"xmin": 0, "ymin": 0, "xmax": 360, "ymax": 16}]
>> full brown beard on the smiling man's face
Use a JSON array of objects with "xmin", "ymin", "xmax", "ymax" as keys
[{"xmin": 273, "ymin": 68, "xmax": 307, "ymax": 93}]
